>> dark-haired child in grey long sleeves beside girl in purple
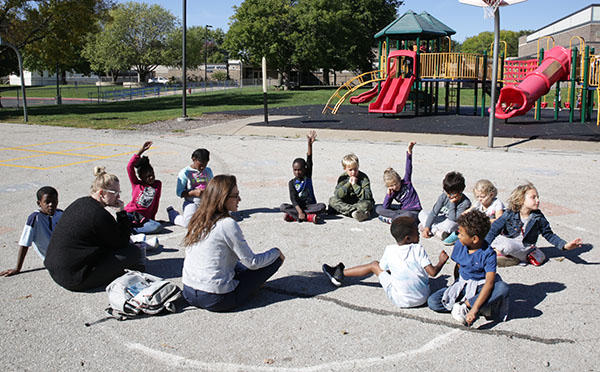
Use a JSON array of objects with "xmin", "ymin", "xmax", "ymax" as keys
[{"xmin": 419, "ymin": 172, "xmax": 471, "ymax": 243}]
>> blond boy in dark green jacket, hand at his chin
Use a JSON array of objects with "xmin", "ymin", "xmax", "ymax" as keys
[{"xmin": 329, "ymin": 154, "xmax": 375, "ymax": 222}]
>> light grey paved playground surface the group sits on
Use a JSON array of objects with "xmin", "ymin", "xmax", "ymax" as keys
[{"xmin": 0, "ymin": 108, "xmax": 600, "ymax": 371}]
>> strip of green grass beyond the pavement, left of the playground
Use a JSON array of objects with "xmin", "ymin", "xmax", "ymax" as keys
[{"xmin": 0, "ymin": 88, "xmax": 333, "ymax": 129}]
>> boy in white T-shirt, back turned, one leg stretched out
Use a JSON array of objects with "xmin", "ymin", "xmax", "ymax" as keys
[{"xmin": 323, "ymin": 216, "xmax": 448, "ymax": 307}]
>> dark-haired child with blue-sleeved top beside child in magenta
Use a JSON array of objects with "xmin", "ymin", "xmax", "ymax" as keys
[{"xmin": 167, "ymin": 149, "xmax": 213, "ymax": 227}]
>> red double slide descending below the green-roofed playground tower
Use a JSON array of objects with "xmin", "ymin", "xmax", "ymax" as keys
[{"xmin": 369, "ymin": 50, "xmax": 416, "ymax": 114}]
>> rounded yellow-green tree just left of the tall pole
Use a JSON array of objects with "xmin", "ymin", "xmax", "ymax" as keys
[{"xmin": 85, "ymin": 2, "xmax": 178, "ymax": 81}]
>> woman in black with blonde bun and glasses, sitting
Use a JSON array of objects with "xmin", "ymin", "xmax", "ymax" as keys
[{"xmin": 44, "ymin": 167, "xmax": 145, "ymax": 291}]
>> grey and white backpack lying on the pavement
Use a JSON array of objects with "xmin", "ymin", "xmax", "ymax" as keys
[{"xmin": 106, "ymin": 270, "xmax": 181, "ymax": 320}]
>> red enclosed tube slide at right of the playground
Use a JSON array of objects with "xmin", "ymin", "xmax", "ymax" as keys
[{"xmin": 496, "ymin": 46, "xmax": 571, "ymax": 119}]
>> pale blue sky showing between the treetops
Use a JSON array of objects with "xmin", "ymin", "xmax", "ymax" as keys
[{"xmin": 119, "ymin": 0, "xmax": 593, "ymax": 42}]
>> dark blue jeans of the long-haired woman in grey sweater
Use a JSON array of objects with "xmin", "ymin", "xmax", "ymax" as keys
[{"xmin": 183, "ymin": 258, "xmax": 283, "ymax": 311}]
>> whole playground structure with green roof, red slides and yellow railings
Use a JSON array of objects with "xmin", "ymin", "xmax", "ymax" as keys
[{"xmin": 323, "ymin": 11, "xmax": 600, "ymax": 124}]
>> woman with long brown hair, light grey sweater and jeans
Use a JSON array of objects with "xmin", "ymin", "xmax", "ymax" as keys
[{"xmin": 182, "ymin": 175, "xmax": 285, "ymax": 311}]
